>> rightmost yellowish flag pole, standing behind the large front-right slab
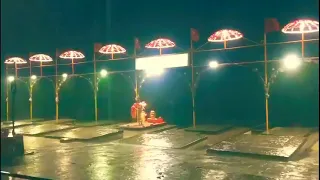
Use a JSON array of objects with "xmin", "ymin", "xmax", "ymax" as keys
[{"xmin": 263, "ymin": 32, "xmax": 269, "ymax": 133}]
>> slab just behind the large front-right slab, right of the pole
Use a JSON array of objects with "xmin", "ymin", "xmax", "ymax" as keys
[{"xmin": 262, "ymin": 127, "xmax": 313, "ymax": 136}]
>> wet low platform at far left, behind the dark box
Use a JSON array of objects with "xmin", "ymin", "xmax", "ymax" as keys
[{"xmin": 10, "ymin": 124, "xmax": 75, "ymax": 136}]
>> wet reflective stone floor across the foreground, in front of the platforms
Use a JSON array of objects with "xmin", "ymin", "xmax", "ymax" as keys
[{"xmin": 1, "ymin": 137, "xmax": 319, "ymax": 180}]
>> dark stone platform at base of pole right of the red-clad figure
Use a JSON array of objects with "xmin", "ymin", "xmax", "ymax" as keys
[{"xmin": 185, "ymin": 125, "xmax": 232, "ymax": 134}]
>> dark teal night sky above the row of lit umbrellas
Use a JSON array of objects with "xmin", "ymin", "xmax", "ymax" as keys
[{"xmin": 1, "ymin": 0, "xmax": 319, "ymax": 54}]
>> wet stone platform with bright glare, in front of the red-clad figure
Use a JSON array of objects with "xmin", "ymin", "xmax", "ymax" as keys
[{"xmin": 120, "ymin": 129, "xmax": 207, "ymax": 149}]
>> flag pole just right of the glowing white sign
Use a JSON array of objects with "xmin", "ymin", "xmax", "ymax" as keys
[{"xmin": 190, "ymin": 29, "xmax": 196, "ymax": 128}]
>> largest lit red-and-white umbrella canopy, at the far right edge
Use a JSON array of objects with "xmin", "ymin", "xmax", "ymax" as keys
[{"xmin": 282, "ymin": 19, "xmax": 319, "ymax": 34}]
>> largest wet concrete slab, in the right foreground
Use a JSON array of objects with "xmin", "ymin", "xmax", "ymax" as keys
[{"xmin": 207, "ymin": 134, "xmax": 306, "ymax": 160}]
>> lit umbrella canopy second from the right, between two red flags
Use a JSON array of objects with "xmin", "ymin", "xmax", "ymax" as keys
[{"xmin": 208, "ymin": 29, "xmax": 243, "ymax": 42}]
